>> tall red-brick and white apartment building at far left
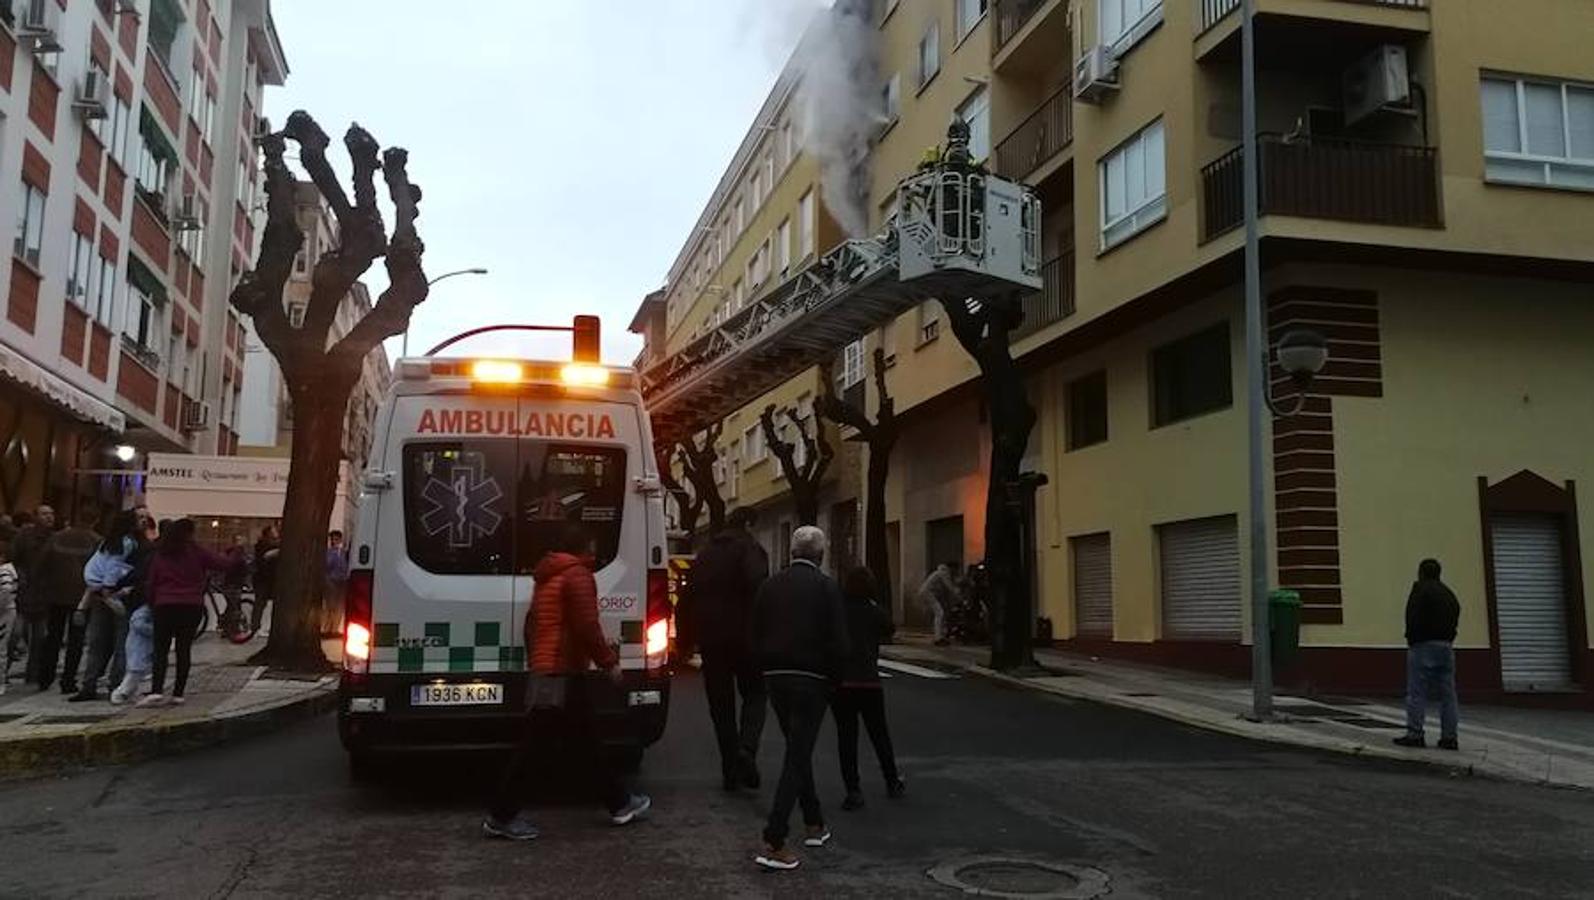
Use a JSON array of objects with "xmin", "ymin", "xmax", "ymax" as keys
[{"xmin": 0, "ymin": 0, "xmax": 287, "ymax": 511}]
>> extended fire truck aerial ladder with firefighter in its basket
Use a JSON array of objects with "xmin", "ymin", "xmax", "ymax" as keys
[{"xmin": 641, "ymin": 121, "xmax": 1041, "ymax": 446}]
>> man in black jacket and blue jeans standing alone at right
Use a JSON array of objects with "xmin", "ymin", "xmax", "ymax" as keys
[{"xmin": 1395, "ymin": 559, "xmax": 1462, "ymax": 750}]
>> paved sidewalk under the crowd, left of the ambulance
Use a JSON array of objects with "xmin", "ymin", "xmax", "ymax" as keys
[{"xmin": 0, "ymin": 632, "xmax": 340, "ymax": 779}]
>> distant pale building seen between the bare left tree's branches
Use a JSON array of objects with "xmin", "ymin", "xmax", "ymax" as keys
[{"xmin": 238, "ymin": 182, "xmax": 392, "ymax": 473}]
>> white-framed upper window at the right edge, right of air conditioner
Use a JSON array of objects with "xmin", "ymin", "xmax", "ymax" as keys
[{"xmin": 1482, "ymin": 76, "xmax": 1594, "ymax": 190}]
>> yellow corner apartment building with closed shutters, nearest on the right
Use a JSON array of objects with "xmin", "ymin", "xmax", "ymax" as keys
[{"xmin": 634, "ymin": 0, "xmax": 1594, "ymax": 696}]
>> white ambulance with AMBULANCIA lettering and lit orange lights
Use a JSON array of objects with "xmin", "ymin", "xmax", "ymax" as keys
[{"xmin": 338, "ymin": 317, "xmax": 673, "ymax": 776}]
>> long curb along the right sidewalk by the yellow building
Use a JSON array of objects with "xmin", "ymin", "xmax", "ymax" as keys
[{"xmin": 880, "ymin": 647, "xmax": 1591, "ymax": 792}]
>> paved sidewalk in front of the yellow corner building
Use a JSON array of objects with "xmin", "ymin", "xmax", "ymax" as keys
[{"xmin": 880, "ymin": 632, "xmax": 1594, "ymax": 788}]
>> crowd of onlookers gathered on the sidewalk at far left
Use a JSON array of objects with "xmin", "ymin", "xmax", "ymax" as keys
[{"xmin": 0, "ymin": 507, "xmax": 293, "ymax": 706}]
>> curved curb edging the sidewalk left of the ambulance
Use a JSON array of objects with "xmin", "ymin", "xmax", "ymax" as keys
[{"xmin": 0, "ymin": 685, "xmax": 338, "ymax": 781}]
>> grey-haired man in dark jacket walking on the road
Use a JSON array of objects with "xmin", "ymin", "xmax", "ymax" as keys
[{"xmin": 752, "ymin": 526, "xmax": 848, "ymax": 870}]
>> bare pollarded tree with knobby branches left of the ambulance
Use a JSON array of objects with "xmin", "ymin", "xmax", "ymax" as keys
[{"xmin": 231, "ymin": 110, "xmax": 427, "ymax": 669}]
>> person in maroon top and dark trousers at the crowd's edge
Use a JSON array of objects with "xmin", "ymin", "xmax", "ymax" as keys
[{"xmin": 139, "ymin": 519, "xmax": 228, "ymax": 706}]
